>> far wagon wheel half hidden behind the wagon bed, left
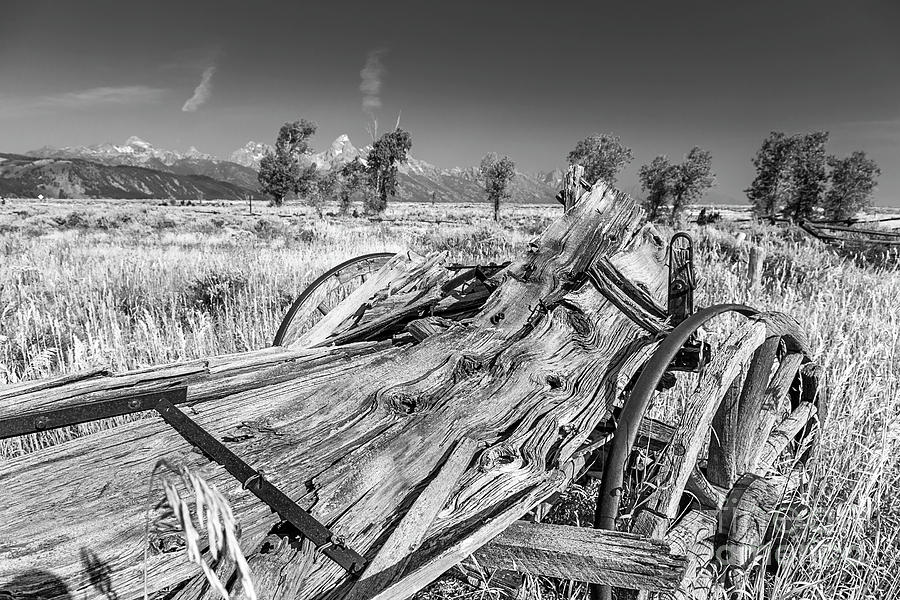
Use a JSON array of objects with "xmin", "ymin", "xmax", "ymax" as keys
[{"xmin": 272, "ymin": 252, "xmax": 394, "ymax": 346}]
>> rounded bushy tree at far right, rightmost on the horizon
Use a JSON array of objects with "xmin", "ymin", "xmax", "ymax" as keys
[{"xmin": 823, "ymin": 151, "xmax": 881, "ymax": 221}]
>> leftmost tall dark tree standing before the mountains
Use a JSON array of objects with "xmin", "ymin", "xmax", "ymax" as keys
[{"xmin": 257, "ymin": 119, "xmax": 316, "ymax": 206}]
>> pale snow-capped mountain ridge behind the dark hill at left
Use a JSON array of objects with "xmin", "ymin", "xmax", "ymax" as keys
[{"xmin": 25, "ymin": 136, "xmax": 259, "ymax": 190}]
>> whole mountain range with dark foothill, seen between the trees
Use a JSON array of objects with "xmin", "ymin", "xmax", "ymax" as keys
[{"xmin": 14, "ymin": 135, "xmax": 562, "ymax": 203}]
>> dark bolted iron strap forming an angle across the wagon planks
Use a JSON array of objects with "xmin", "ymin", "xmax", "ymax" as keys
[{"xmin": 0, "ymin": 387, "xmax": 366, "ymax": 574}]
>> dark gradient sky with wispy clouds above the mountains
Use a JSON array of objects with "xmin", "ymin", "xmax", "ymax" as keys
[{"xmin": 0, "ymin": 0, "xmax": 900, "ymax": 206}]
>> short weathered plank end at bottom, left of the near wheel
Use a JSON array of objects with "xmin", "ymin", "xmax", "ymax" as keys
[{"xmin": 474, "ymin": 521, "xmax": 687, "ymax": 591}]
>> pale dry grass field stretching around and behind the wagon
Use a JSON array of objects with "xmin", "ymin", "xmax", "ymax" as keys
[{"xmin": 0, "ymin": 200, "xmax": 900, "ymax": 599}]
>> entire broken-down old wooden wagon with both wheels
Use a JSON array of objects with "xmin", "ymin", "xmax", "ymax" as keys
[{"xmin": 0, "ymin": 178, "xmax": 823, "ymax": 600}]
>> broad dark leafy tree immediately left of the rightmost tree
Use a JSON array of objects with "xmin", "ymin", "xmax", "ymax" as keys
[{"xmin": 746, "ymin": 131, "xmax": 828, "ymax": 219}]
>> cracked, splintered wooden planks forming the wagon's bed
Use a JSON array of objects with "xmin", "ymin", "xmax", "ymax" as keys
[{"xmin": 0, "ymin": 183, "xmax": 676, "ymax": 600}]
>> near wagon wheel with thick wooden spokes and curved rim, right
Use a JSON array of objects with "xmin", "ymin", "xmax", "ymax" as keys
[{"xmin": 591, "ymin": 305, "xmax": 824, "ymax": 599}]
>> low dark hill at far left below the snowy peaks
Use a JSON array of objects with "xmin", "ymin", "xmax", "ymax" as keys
[{"xmin": 0, "ymin": 154, "xmax": 255, "ymax": 200}]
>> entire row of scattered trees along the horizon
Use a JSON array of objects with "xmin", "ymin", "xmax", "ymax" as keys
[{"xmin": 259, "ymin": 119, "xmax": 881, "ymax": 225}]
